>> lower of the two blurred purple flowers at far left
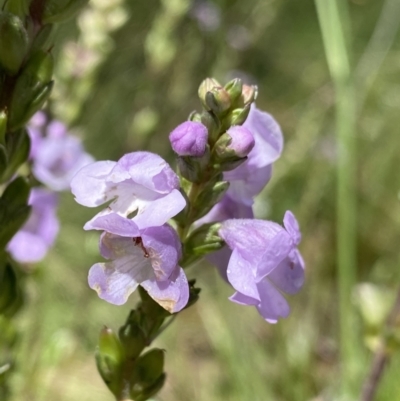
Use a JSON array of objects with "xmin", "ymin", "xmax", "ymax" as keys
[{"xmin": 7, "ymin": 188, "xmax": 59, "ymax": 263}]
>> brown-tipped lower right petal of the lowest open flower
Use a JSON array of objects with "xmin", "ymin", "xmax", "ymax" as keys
[{"xmin": 141, "ymin": 267, "xmax": 189, "ymax": 313}]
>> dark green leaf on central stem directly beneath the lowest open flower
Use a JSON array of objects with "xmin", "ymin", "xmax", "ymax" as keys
[{"xmin": 118, "ymin": 310, "xmax": 146, "ymax": 359}]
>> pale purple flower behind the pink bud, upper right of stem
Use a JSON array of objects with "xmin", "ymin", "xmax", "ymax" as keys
[{"xmin": 224, "ymin": 104, "xmax": 283, "ymax": 206}]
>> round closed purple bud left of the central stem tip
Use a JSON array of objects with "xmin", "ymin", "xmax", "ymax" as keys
[{"xmin": 169, "ymin": 121, "xmax": 208, "ymax": 157}]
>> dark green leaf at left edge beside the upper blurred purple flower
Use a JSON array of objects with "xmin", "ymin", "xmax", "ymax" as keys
[{"xmin": 0, "ymin": 129, "xmax": 31, "ymax": 182}]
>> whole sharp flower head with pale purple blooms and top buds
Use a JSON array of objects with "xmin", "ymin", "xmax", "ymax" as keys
[{"xmin": 71, "ymin": 79, "xmax": 304, "ymax": 323}]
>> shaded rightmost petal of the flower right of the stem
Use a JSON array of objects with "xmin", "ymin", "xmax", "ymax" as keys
[{"xmin": 268, "ymin": 249, "xmax": 304, "ymax": 294}]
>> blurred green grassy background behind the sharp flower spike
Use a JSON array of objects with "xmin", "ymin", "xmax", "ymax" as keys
[{"xmin": 4, "ymin": 0, "xmax": 400, "ymax": 401}]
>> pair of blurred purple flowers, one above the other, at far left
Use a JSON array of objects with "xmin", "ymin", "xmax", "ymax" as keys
[{"xmin": 7, "ymin": 112, "xmax": 94, "ymax": 263}]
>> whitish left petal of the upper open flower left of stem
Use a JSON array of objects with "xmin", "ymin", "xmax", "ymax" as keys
[{"xmin": 71, "ymin": 161, "xmax": 116, "ymax": 207}]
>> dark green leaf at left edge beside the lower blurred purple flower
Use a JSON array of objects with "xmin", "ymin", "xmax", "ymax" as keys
[{"xmin": 0, "ymin": 177, "xmax": 31, "ymax": 249}]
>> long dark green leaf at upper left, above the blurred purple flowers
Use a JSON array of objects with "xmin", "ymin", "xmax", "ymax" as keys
[{"xmin": 8, "ymin": 50, "xmax": 54, "ymax": 131}]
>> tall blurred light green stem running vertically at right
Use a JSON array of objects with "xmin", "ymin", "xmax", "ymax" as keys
[{"xmin": 315, "ymin": 0, "xmax": 359, "ymax": 394}]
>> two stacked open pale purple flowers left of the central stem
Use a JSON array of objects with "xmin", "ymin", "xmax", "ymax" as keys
[{"xmin": 71, "ymin": 152, "xmax": 189, "ymax": 313}]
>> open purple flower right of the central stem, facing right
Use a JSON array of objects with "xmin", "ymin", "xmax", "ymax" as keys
[{"xmin": 219, "ymin": 211, "xmax": 304, "ymax": 323}]
